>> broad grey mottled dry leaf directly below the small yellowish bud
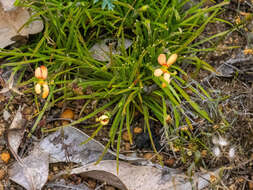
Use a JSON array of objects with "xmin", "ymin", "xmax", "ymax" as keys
[{"xmin": 39, "ymin": 127, "xmax": 113, "ymax": 165}]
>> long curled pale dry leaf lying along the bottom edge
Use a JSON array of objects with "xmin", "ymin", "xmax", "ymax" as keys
[{"xmin": 70, "ymin": 160, "xmax": 217, "ymax": 190}]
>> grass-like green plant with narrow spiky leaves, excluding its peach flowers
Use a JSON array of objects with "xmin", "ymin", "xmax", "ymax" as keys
[{"xmin": 0, "ymin": 0, "xmax": 229, "ymax": 164}]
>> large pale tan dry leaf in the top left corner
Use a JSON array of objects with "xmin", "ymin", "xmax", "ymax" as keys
[{"xmin": 0, "ymin": 0, "xmax": 43, "ymax": 48}]
